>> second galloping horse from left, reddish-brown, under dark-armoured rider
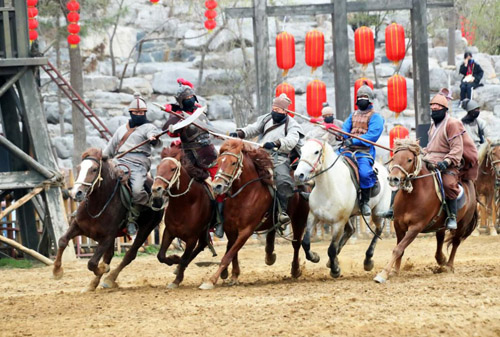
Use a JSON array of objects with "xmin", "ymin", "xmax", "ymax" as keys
[{"xmin": 152, "ymin": 145, "xmax": 213, "ymax": 288}]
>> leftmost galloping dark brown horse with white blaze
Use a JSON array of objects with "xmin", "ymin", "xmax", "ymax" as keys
[{"xmin": 52, "ymin": 148, "xmax": 162, "ymax": 291}]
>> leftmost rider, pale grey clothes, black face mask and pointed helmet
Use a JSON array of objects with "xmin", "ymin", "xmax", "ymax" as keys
[{"xmin": 103, "ymin": 93, "xmax": 162, "ymax": 235}]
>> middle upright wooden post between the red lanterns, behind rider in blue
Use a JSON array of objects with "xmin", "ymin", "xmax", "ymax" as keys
[{"xmin": 332, "ymin": 0, "xmax": 351, "ymax": 120}]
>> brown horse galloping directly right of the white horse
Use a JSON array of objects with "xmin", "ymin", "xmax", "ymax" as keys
[{"xmin": 374, "ymin": 139, "xmax": 478, "ymax": 283}]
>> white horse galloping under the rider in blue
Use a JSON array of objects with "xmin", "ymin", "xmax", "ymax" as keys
[{"xmin": 294, "ymin": 139, "xmax": 391, "ymax": 278}]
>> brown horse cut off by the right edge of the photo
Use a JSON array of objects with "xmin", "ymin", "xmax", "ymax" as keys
[{"xmin": 476, "ymin": 140, "xmax": 500, "ymax": 235}]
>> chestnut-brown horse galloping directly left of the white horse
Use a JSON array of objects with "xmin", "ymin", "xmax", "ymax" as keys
[{"xmin": 200, "ymin": 139, "xmax": 309, "ymax": 289}]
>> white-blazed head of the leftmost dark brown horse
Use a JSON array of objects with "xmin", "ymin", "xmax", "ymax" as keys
[{"xmin": 71, "ymin": 148, "xmax": 107, "ymax": 202}]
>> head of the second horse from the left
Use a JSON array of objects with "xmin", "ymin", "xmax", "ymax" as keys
[{"xmin": 151, "ymin": 144, "xmax": 183, "ymax": 209}]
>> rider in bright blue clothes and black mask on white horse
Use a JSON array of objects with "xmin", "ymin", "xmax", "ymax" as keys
[{"xmin": 340, "ymin": 84, "xmax": 384, "ymax": 216}]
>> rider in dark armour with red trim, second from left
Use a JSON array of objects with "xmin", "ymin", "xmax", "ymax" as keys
[{"xmin": 163, "ymin": 78, "xmax": 224, "ymax": 238}]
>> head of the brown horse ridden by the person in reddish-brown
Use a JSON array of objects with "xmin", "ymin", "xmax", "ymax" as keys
[{"xmin": 387, "ymin": 139, "xmax": 422, "ymax": 189}]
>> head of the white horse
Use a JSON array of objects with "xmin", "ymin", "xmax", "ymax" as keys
[{"xmin": 294, "ymin": 139, "xmax": 325, "ymax": 182}]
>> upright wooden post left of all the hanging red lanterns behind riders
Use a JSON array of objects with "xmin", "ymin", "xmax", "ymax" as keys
[{"xmin": 253, "ymin": 0, "xmax": 271, "ymax": 115}]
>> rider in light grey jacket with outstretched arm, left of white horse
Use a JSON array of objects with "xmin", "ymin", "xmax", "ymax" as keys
[{"xmin": 229, "ymin": 94, "xmax": 304, "ymax": 228}]
